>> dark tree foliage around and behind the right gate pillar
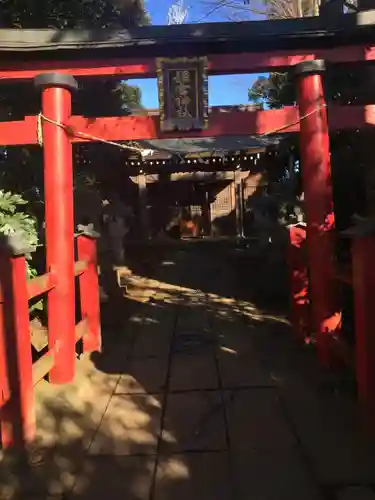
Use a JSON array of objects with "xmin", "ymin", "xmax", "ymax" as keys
[{"xmin": 249, "ymin": 55, "xmax": 375, "ymax": 235}]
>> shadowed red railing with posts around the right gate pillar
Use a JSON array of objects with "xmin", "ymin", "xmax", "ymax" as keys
[{"xmin": 289, "ymin": 227, "xmax": 375, "ymax": 417}]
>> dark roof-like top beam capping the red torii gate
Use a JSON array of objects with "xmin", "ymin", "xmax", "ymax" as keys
[{"xmin": 0, "ymin": 10, "xmax": 375, "ymax": 59}]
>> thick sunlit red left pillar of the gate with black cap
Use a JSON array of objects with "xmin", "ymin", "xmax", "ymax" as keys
[{"xmin": 35, "ymin": 73, "xmax": 77, "ymax": 384}]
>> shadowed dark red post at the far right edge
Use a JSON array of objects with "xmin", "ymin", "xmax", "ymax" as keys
[{"xmin": 352, "ymin": 235, "xmax": 375, "ymax": 416}]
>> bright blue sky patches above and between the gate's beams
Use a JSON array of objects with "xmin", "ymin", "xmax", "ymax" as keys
[{"xmin": 129, "ymin": 0, "xmax": 264, "ymax": 109}]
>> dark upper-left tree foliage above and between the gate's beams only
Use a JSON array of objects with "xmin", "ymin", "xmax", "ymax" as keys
[{"xmin": 0, "ymin": 0, "xmax": 150, "ymax": 120}]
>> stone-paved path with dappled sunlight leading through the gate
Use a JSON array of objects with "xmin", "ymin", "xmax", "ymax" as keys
[{"xmin": 0, "ymin": 242, "xmax": 375, "ymax": 500}]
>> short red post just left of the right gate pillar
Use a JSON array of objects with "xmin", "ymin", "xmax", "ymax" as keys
[{"xmin": 288, "ymin": 224, "xmax": 311, "ymax": 342}]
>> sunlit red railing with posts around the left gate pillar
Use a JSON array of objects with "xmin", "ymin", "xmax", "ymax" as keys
[{"xmin": 0, "ymin": 233, "xmax": 101, "ymax": 448}]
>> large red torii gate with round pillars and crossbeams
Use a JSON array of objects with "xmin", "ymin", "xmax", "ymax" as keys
[{"xmin": 0, "ymin": 17, "xmax": 375, "ymax": 444}]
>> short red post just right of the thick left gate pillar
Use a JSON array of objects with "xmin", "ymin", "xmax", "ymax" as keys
[{"xmin": 77, "ymin": 231, "xmax": 102, "ymax": 352}]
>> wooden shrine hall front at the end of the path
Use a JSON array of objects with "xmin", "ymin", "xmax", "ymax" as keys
[{"xmin": 134, "ymin": 142, "xmax": 268, "ymax": 240}]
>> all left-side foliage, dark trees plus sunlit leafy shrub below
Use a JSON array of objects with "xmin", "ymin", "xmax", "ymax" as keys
[{"xmin": 0, "ymin": 0, "xmax": 150, "ymax": 311}]
